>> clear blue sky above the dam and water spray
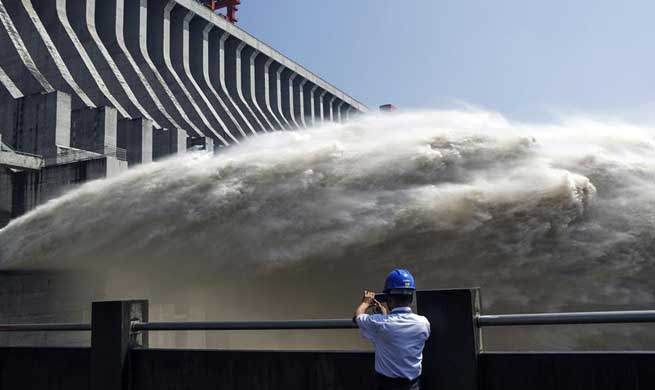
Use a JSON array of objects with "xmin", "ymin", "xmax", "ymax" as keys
[{"xmin": 239, "ymin": 0, "xmax": 655, "ymax": 122}]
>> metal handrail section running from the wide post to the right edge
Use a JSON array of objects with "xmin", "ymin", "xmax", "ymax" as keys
[{"xmin": 477, "ymin": 310, "xmax": 655, "ymax": 327}]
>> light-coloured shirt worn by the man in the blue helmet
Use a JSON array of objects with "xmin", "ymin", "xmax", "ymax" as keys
[{"xmin": 355, "ymin": 307, "xmax": 430, "ymax": 380}]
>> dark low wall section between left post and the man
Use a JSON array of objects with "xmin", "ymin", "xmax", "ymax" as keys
[{"xmin": 130, "ymin": 349, "xmax": 374, "ymax": 390}]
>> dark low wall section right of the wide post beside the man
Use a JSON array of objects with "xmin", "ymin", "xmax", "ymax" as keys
[{"xmin": 479, "ymin": 352, "xmax": 655, "ymax": 390}]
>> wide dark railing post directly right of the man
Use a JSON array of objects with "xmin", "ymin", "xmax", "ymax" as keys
[{"xmin": 416, "ymin": 288, "xmax": 481, "ymax": 390}]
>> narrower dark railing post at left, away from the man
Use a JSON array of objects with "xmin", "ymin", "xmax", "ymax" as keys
[{"xmin": 91, "ymin": 300, "xmax": 148, "ymax": 390}]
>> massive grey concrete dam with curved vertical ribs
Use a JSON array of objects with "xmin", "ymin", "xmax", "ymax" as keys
[{"xmin": 0, "ymin": 0, "xmax": 367, "ymax": 227}]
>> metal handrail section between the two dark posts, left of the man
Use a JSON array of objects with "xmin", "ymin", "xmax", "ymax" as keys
[{"xmin": 132, "ymin": 319, "xmax": 357, "ymax": 331}]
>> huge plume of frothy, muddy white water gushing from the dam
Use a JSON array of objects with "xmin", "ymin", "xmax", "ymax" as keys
[{"xmin": 0, "ymin": 111, "xmax": 655, "ymax": 350}]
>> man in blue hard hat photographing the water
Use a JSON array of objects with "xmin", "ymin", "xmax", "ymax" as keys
[{"xmin": 353, "ymin": 269, "xmax": 430, "ymax": 390}]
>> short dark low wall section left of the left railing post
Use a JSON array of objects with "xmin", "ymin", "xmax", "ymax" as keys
[{"xmin": 0, "ymin": 348, "xmax": 91, "ymax": 390}]
